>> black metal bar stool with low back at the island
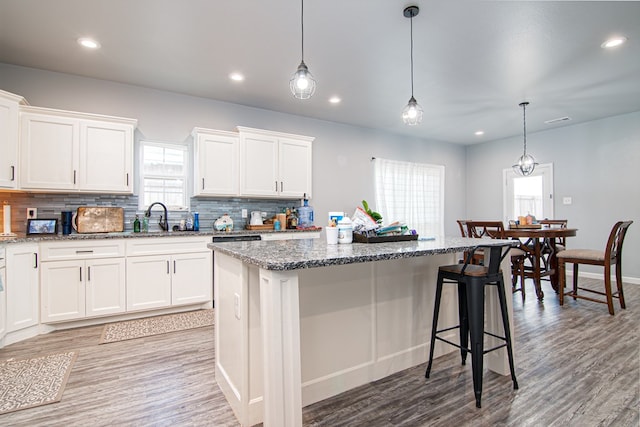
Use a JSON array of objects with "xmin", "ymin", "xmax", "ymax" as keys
[{"xmin": 425, "ymin": 244, "xmax": 518, "ymax": 408}]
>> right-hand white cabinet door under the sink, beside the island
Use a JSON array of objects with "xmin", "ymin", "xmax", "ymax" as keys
[{"xmin": 171, "ymin": 251, "xmax": 213, "ymax": 305}]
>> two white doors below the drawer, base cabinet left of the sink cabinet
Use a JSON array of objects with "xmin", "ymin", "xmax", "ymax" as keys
[{"xmin": 40, "ymin": 257, "xmax": 126, "ymax": 323}]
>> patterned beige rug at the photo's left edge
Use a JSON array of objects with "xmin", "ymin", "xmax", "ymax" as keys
[{"xmin": 0, "ymin": 351, "xmax": 78, "ymax": 414}]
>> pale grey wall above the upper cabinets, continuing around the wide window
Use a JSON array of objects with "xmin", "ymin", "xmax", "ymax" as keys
[{"xmin": 0, "ymin": 63, "xmax": 465, "ymax": 235}]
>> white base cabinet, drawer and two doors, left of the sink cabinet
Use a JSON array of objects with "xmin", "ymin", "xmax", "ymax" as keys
[{"xmin": 40, "ymin": 239, "xmax": 126, "ymax": 323}]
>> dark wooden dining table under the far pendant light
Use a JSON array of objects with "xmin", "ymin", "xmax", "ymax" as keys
[{"xmin": 504, "ymin": 225, "xmax": 578, "ymax": 300}]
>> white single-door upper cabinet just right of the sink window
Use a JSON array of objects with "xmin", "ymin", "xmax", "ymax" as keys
[{"xmin": 192, "ymin": 128, "xmax": 240, "ymax": 196}]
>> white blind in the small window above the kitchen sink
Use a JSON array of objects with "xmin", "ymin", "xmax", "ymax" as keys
[{"xmin": 139, "ymin": 141, "xmax": 189, "ymax": 210}]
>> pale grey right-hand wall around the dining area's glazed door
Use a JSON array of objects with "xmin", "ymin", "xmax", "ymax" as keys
[{"xmin": 466, "ymin": 112, "xmax": 640, "ymax": 280}]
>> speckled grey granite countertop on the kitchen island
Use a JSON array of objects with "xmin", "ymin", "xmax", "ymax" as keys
[{"xmin": 207, "ymin": 237, "xmax": 518, "ymax": 271}]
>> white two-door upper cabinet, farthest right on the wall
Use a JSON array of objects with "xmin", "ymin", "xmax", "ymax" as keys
[{"xmin": 238, "ymin": 127, "xmax": 314, "ymax": 198}]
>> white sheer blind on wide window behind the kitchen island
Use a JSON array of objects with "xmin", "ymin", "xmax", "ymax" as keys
[{"xmin": 373, "ymin": 158, "xmax": 444, "ymax": 237}]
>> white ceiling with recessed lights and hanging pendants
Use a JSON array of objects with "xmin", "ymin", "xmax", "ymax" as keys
[{"xmin": 0, "ymin": 0, "xmax": 640, "ymax": 144}]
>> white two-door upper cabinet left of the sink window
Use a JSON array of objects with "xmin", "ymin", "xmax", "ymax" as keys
[{"xmin": 20, "ymin": 107, "xmax": 137, "ymax": 194}]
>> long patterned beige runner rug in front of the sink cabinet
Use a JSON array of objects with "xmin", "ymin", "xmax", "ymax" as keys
[{"xmin": 100, "ymin": 309, "xmax": 213, "ymax": 344}]
